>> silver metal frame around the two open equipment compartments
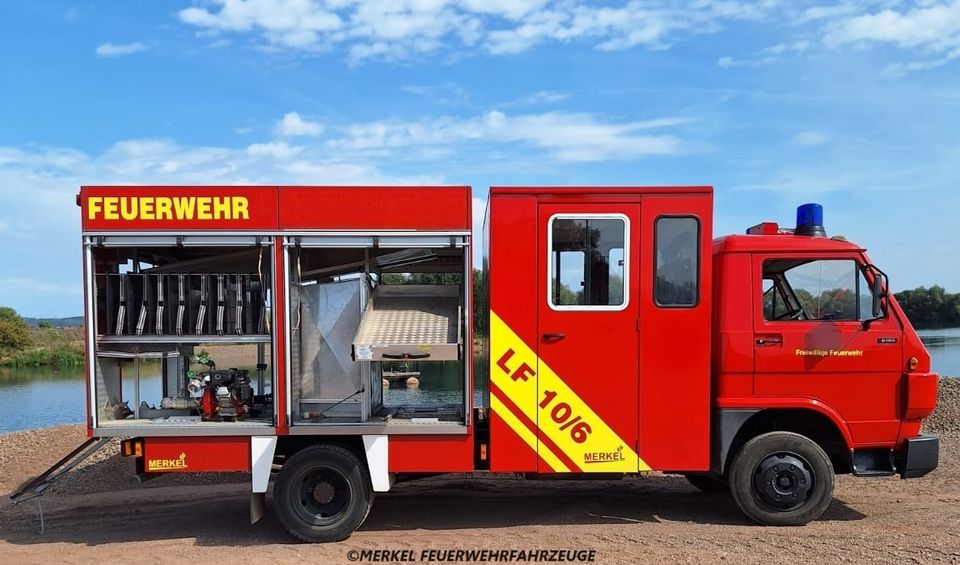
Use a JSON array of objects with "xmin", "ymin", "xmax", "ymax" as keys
[{"xmin": 82, "ymin": 230, "xmax": 473, "ymax": 437}]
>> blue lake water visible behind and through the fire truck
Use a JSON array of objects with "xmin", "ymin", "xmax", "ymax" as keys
[{"xmin": 0, "ymin": 328, "xmax": 960, "ymax": 433}]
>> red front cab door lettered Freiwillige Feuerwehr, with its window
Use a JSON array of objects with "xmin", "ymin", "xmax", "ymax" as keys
[{"xmin": 753, "ymin": 253, "xmax": 903, "ymax": 446}]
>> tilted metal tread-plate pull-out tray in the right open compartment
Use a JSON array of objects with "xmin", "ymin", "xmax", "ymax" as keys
[{"xmin": 353, "ymin": 285, "xmax": 462, "ymax": 361}]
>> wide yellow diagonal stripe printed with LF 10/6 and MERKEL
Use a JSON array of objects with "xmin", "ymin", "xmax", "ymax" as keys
[{"xmin": 490, "ymin": 310, "xmax": 650, "ymax": 473}]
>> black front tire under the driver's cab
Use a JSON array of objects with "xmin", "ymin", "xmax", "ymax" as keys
[{"xmin": 730, "ymin": 432, "xmax": 833, "ymax": 526}]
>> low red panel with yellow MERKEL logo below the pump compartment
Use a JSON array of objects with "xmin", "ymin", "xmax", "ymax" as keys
[{"xmin": 143, "ymin": 437, "xmax": 250, "ymax": 473}]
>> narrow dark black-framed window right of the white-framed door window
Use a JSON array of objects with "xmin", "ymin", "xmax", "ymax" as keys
[{"xmin": 653, "ymin": 216, "xmax": 700, "ymax": 307}]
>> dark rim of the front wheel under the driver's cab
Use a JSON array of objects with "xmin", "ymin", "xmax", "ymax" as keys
[{"xmin": 753, "ymin": 451, "xmax": 817, "ymax": 512}]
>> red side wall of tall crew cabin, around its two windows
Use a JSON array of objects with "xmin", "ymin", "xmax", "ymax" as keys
[{"xmin": 486, "ymin": 187, "xmax": 712, "ymax": 472}]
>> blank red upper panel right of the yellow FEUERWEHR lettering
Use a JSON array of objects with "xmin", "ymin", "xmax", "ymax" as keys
[{"xmin": 280, "ymin": 186, "xmax": 471, "ymax": 230}]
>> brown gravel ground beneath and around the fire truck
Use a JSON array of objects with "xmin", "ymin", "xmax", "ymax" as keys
[{"xmin": 0, "ymin": 379, "xmax": 960, "ymax": 563}]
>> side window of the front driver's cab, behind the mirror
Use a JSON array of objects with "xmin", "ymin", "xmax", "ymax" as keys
[{"xmin": 763, "ymin": 259, "xmax": 873, "ymax": 321}]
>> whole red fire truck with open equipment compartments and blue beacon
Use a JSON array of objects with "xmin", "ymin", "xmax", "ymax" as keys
[{"xmin": 9, "ymin": 186, "xmax": 938, "ymax": 541}]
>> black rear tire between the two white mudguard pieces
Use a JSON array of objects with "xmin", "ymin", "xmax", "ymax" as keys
[{"xmin": 273, "ymin": 445, "xmax": 373, "ymax": 542}]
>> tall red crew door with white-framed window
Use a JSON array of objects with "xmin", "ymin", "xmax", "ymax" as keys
[{"xmin": 536, "ymin": 203, "xmax": 640, "ymax": 472}]
